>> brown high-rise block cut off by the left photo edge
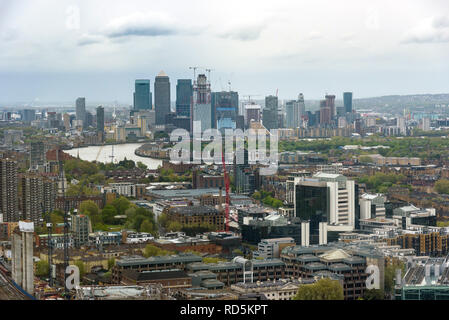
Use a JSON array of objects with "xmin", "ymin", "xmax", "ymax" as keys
[{"xmin": 0, "ymin": 159, "xmax": 20, "ymax": 222}]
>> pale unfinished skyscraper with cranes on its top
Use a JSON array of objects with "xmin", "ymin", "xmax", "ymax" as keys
[{"xmin": 190, "ymin": 74, "xmax": 212, "ymax": 132}]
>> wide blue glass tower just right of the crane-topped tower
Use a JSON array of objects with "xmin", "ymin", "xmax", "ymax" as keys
[{"xmin": 211, "ymin": 91, "xmax": 239, "ymax": 130}]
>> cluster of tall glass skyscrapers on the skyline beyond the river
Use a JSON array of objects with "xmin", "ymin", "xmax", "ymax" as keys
[{"xmin": 127, "ymin": 71, "xmax": 354, "ymax": 136}]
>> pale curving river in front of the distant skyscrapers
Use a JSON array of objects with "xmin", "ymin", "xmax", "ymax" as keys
[{"xmin": 64, "ymin": 143, "xmax": 162, "ymax": 170}]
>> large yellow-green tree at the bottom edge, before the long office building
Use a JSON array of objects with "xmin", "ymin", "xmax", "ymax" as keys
[{"xmin": 293, "ymin": 278, "xmax": 344, "ymax": 300}]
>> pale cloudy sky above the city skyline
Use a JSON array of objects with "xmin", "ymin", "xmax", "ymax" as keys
[{"xmin": 0, "ymin": 0, "xmax": 449, "ymax": 104}]
